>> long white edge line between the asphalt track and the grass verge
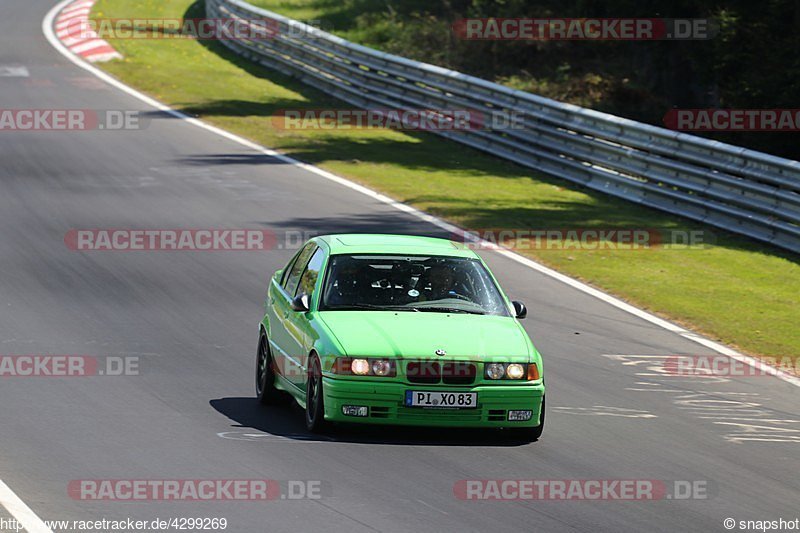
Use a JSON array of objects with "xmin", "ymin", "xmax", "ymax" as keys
[{"xmin": 42, "ymin": 0, "xmax": 800, "ymax": 387}]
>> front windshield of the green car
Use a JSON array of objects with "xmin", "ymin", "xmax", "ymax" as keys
[{"xmin": 320, "ymin": 255, "xmax": 509, "ymax": 316}]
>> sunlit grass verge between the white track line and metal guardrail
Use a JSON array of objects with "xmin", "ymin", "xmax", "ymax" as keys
[{"xmin": 93, "ymin": 0, "xmax": 800, "ymax": 370}]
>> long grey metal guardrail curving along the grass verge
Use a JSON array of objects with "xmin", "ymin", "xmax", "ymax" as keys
[{"xmin": 206, "ymin": 0, "xmax": 800, "ymax": 252}]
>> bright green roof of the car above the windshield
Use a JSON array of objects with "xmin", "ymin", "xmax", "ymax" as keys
[{"xmin": 317, "ymin": 233, "xmax": 478, "ymax": 258}]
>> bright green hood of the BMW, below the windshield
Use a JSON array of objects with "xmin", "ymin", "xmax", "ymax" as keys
[{"xmin": 319, "ymin": 311, "xmax": 530, "ymax": 361}]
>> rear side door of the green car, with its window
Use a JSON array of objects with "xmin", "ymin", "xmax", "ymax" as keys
[{"xmin": 267, "ymin": 242, "xmax": 317, "ymax": 383}]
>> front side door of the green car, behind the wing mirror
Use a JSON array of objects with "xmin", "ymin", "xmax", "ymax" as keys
[{"xmin": 286, "ymin": 248, "xmax": 326, "ymax": 389}]
